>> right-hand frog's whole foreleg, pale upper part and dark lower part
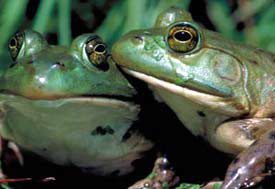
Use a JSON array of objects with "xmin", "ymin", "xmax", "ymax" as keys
[{"xmin": 210, "ymin": 118, "xmax": 275, "ymax": 189}]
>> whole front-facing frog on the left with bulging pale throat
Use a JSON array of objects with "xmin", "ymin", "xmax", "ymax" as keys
[{"xmin": 0, "ymin": 30, "xmax": 152, "ymax": 175}]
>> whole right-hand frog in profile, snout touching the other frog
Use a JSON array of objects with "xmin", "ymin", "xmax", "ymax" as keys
[{"xmin": 112, "ymin": 8, "xmax": 275, "ymax": 189}]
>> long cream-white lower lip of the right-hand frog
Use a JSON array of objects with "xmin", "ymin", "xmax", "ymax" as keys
[{"xmin": 121, "ymin": 67, "xmax": 247, "ymax": 116}]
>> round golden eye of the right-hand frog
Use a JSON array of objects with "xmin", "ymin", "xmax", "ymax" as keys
[{"xmin": 167, "ymin": 23, "xmax": 199, "ymax": 53}]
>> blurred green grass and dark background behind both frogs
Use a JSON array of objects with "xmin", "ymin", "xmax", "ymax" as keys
[{"xmin": 0, "ymin": 0, "xmax": 275, "ymax": 56}]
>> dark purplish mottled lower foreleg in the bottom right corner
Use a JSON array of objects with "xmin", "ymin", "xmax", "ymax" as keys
[{"xmin": 221, "ymin": 127, "xmax": 275, "ymax": 189}]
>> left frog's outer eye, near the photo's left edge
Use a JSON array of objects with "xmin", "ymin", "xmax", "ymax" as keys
[{"xmin": 9, "ymin": 32, "xmax": 24, "ymax": 60}]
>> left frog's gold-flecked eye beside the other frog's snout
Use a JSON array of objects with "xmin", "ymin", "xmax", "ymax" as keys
[{"xmin": 85, "ymin": 36, "xmax": 109, "ymax": 71}]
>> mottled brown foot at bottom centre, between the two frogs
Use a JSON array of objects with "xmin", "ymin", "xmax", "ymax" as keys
[{"xmin": 128, "ymin": 157, "xmax": 179, "ymax": 189}]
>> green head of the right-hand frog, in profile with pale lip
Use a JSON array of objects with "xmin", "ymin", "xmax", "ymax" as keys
[{"xmin": 112, "ymin": 7, "xmax": 251, "ymax": 115}]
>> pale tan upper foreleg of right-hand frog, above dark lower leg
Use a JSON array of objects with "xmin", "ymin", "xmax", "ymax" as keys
[{"xmin": 208, "ymin": 118, "xmax": 274, "ymax": 155}]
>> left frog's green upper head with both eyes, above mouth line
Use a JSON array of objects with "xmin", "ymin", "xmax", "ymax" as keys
[{"xmin": 0, "ymin": 30, "xmax": 136, "ymax": 99}]
